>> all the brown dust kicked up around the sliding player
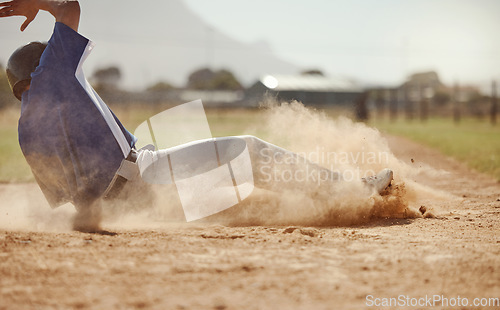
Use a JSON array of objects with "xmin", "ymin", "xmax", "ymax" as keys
[{"xmin": 0, "ymin": 100, "xmax": 450, "ymax": 231}]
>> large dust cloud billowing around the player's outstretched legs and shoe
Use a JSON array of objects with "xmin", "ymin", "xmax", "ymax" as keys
[{"xmin": 201, "ymin": 99, "xmax": 449, "ymax": 226}]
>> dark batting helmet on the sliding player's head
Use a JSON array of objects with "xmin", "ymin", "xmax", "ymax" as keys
[{"xmin": 6, "ymin": 42, "xmax": 47, "ymax": 100}]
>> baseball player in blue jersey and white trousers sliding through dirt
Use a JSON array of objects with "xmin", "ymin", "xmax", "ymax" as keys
[{"xmin": 0, "ymin": 0, "xmax": 393, "ymax": 231}]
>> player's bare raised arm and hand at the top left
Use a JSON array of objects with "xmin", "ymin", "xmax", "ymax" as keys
[{"xmin": 0, "ymin": 0, "xmax": 80, "ymax": 31}]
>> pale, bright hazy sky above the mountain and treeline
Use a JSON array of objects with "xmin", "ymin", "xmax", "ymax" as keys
[{"xmin": 0, "ymin": 0, "xmax": 500, "ymax": 92}]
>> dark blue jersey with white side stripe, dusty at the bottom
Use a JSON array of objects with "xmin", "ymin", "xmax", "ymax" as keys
[{"xmin": 19, "ymin": 22, "xmax": 136, "ymax": 208}]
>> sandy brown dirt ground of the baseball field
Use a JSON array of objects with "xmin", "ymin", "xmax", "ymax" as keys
[{"xmin": 0, "ymin": 137, "xmax": 500, "ymax": 309}]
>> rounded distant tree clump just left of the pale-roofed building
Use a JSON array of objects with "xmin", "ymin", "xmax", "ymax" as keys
[{"xmin": 187, "ymin": 68, "xmax": 243, "ymax": 90}]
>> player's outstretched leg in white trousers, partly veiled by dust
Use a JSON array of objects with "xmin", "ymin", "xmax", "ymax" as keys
[{"xmin": 137, "ymin": 136, "xmax": 392, "ymax": 192}]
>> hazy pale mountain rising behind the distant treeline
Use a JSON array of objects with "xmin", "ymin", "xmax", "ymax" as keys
[{"xmin": 80, "ymin": 0, "xmax": 298, "ymax": 86}]
